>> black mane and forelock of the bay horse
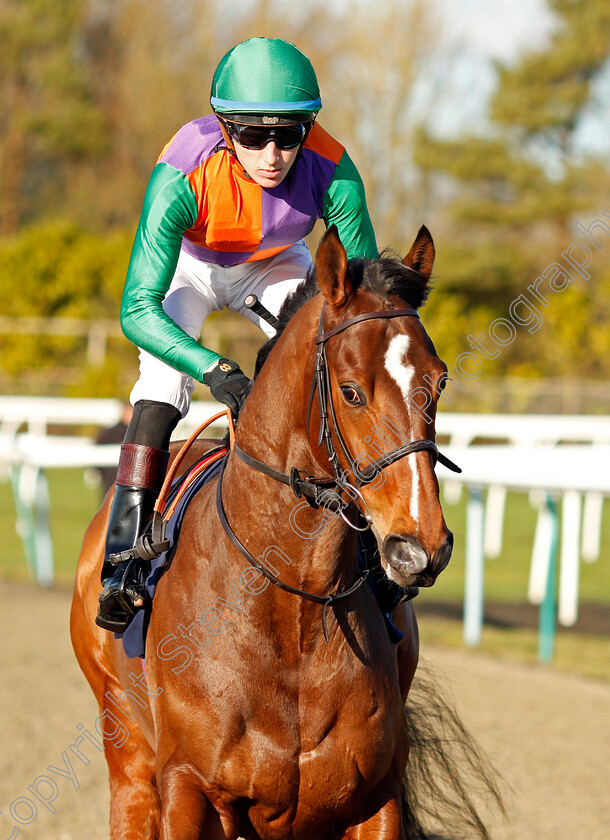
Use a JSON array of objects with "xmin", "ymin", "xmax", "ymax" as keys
[{"xmin": 254, "ymin": 251, "xmax": 430, "ymax": 378}]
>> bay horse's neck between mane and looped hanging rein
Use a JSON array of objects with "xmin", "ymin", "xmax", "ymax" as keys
[{"xmin": 223, "ymin": 312, "xmax": 355, "ymax": 594}]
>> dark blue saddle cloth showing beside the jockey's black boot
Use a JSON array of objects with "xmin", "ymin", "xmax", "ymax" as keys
[{"xmin": 115, "ymin": 459, "xmax": 222, "ymax": 657}]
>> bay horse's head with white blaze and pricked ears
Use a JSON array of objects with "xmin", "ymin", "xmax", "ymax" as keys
[{"xmin": 316, "ymin": 227, "xmax": 453, "ymax": 586}]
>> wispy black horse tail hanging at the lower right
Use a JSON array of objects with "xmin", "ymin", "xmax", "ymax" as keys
[{"xmin": 402, "ymin": 664, "xmax": 506, "ymax": 840}]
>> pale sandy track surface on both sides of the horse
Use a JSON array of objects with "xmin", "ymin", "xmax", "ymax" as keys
[{"xmin": 0, "ymin": 582, "xmax": 610, "ymax": 840}]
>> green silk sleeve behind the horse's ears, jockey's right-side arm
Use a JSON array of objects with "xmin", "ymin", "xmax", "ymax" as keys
[{"xmin": 323, "ymin": 151, "xmax": 379, "ymax": 259}]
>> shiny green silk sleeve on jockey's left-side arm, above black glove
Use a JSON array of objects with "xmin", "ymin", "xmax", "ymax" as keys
[{"xmin": 121, "ymin": 163, "xmax": 220, "ymax": 382}]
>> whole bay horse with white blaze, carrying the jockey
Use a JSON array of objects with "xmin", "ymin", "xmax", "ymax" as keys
[{"xmin": 71, "ymin": 227, "xmax": 490, "ymax": 840}]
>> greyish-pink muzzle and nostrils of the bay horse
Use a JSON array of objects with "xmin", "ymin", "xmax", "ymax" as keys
[{"xmin": 381, "ymin": 531, "xmax": 453, "ymax": 586}]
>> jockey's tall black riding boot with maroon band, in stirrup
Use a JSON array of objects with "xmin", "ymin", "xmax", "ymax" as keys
[{"xmin": 95, "ymin": 400, "xmax": 180, "ymax": 633}]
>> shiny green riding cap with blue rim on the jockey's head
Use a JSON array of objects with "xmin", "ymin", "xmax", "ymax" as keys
[{"xmin": 210, "ymin": 38, "xmax": 322, "ymax": 120}]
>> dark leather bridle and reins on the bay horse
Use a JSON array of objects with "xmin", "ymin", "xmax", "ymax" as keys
[{"xmin": 216, "ymin": 304, "xmax": 461, "ymax": 641}]
